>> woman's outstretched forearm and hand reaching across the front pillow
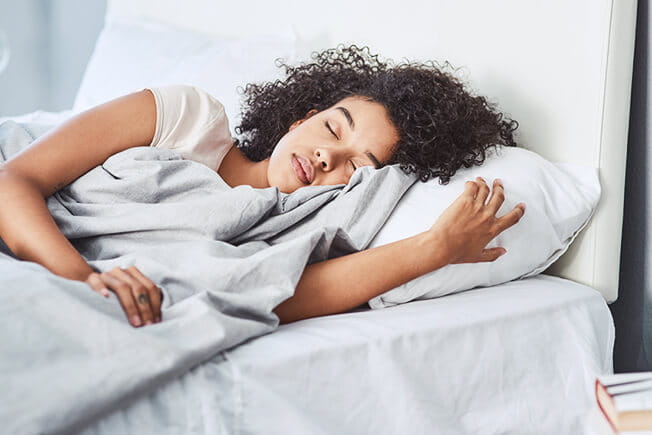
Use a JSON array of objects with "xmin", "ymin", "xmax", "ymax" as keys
[{"xmin": 274, "ymin": 179, "xmax": 525, "ymax": 324}]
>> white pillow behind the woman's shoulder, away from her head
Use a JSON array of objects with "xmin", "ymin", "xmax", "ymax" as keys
[{"xmin": 73, "ymin": 18, "xmax": 297, "ymax": 134}]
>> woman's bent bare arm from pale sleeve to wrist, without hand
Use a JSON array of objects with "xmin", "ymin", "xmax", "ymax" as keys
[{"xmin": 0, "ymin": 90, "xmax": 156, "ymax": 281}]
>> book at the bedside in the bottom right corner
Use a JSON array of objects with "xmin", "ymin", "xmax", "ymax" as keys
[{"xmin": 595, "ymin": 372, "xmax": 652, "ymax": 432}]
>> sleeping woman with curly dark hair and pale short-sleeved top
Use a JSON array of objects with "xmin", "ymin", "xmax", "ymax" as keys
[{"xmin": 0, "ymin": 46, "xmax": 525, "ymax": 327}]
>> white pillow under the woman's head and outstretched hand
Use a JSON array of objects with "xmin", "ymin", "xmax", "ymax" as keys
[{"xmin": 369, "ymin": 146, "xmax": 600, "ymax": 308}]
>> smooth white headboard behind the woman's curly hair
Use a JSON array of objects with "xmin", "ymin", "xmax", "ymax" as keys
[{"xmin": 107, "ymin": 0, "xmax": 636, "ymax": 302}]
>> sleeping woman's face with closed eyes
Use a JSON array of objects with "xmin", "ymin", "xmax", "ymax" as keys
[{"xmin": 267, "ymin": 96, "xmax": 399, "ymax": 193}]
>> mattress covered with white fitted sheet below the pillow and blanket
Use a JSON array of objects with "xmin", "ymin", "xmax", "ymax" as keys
[{"xmin": 79, "ymin": 275, "xmax": 614, "ymax": 435}]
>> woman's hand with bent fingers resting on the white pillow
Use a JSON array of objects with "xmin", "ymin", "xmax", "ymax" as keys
[{"xmin": 429, "ymin": 177, "xmax": 525, "ymax": 264}]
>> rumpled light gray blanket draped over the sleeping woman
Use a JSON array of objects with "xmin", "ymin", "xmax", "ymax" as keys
[{"xmin": 0, "ymin": 121, "xmax": 416, "ymax": 434}]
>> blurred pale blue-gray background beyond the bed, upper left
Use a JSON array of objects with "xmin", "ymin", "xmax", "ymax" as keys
[{"xmin": 0, "ymin": 0, "xmax": 106, "ymax": 117}]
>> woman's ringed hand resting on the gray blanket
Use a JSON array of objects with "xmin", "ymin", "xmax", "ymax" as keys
[{"xmin": 85, "ymin": 266, "xmax": 161, "ymax": 326}]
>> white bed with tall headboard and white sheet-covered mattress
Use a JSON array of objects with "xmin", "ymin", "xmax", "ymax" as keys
[{"xmin": 0, "ymin": 0, "xmax": 636, "ymax": 434}]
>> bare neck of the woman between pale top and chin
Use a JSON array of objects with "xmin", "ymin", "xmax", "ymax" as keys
[{"xmin": 217, "ymin": 146, "xmax": 269, "ymax": 188}]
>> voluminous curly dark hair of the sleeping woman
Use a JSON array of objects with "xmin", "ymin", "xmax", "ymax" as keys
[{"xmin": 235, "ymin": 44, "xmax": 518, "ymax": 184}]
